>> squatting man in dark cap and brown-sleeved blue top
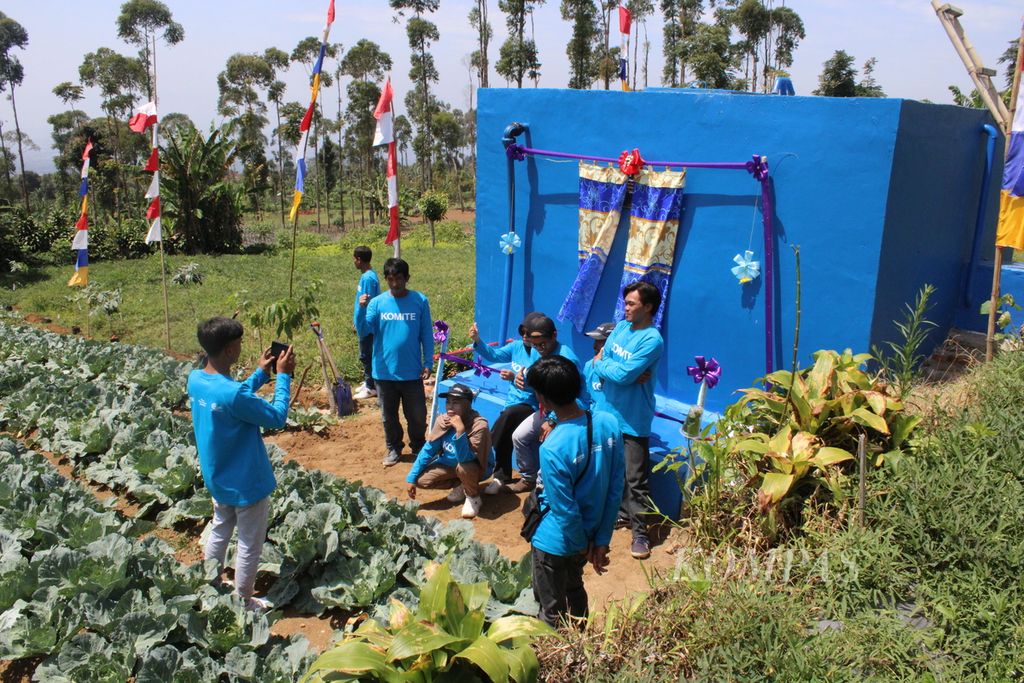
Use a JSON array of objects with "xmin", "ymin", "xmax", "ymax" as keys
[{"xmin": 406, "ymin": 384, "xmax": 495, "ymax": 519}]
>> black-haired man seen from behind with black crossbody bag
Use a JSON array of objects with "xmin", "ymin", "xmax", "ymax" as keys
[{"xmin": 527, "ymin": 355, "xmax": 623, "ymax": 626}]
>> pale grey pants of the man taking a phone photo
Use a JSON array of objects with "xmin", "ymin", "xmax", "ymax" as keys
[{"xmin": 203, "ymin": 496, "xmax": 270, "ymax": 599}]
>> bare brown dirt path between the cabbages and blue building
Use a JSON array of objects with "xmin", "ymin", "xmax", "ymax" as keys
[{"xmin": 266, "ymin": 400, "xmax": 678, "ymax": 610}]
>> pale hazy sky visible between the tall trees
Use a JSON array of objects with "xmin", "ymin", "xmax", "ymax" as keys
[{"xmin": 0, "ymin": 0, "xmax": 1024, "ymax": 172}]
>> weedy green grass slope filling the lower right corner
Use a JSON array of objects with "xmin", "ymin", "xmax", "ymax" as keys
[{"xmin": 542, "ymin": 352, "xmax": 1024, "ymax": 681}]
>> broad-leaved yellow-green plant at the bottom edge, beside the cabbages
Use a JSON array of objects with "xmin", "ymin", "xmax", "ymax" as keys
[{"xmin": 302, "ymin": 563, "xmax": 555, "ymax": 683}]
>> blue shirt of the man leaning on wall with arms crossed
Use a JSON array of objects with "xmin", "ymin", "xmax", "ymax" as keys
[{"xmin": 593, "ymin": 321, "xmax": 665, "ymax": 436}]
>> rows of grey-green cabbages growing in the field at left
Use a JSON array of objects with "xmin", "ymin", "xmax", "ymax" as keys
[{"xmin": 0, "ymin": 321, "xmax": 536, "ymax": 682}]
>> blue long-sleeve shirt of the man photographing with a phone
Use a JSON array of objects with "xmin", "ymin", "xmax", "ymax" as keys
[{"xmin": 188, "ymin": 368, "xmax": 292, "ymax": 507}]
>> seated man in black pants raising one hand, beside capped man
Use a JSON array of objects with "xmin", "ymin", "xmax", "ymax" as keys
[{"xmin": 469, "ymin": 312, "xmax": 541, "ymax": 496}]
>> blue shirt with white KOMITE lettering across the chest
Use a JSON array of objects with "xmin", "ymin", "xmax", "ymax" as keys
[{"xmin": 355, "ymin": 290, "xmax": 434, "ymax": 382}]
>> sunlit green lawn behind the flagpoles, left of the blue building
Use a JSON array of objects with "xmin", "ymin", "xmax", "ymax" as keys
[{"xmin": 0, "ymin": 221, "xmax": 476, "ymax": 384}]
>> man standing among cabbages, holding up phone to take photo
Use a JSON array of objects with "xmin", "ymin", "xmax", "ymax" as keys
[{"xmin": 188, "ymin": 317, "xmax": 295, "ymax": 609}]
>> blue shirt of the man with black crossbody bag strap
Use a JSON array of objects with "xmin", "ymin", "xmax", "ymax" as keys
[{"xmin": 531, "ymin": 413, "xmax": 626, "ymax": 557}]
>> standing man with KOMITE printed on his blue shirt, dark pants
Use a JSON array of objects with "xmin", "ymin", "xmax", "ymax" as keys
[{"xmin": 355, "ymin": 258, "xmax": 434, "ymax": 467}]
